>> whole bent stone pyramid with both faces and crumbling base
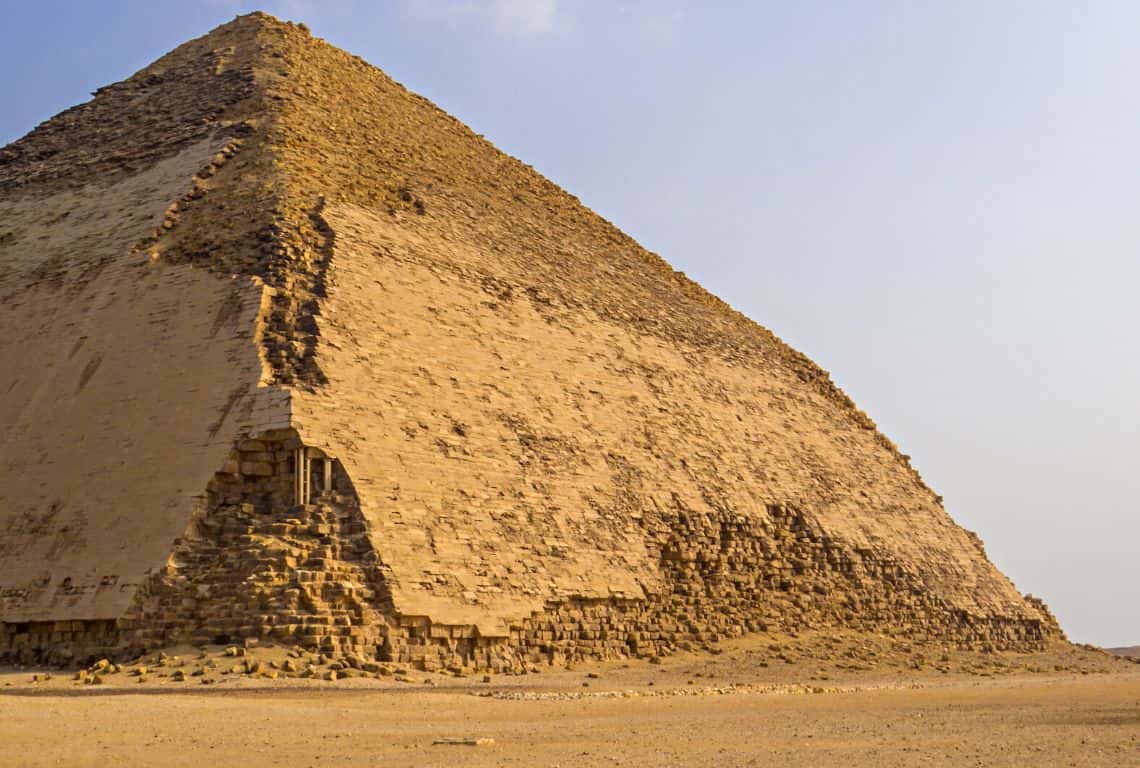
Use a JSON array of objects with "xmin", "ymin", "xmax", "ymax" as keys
[{"xmin": 0, "ymin": 14, "xmax": 1060, "ymax": 667}]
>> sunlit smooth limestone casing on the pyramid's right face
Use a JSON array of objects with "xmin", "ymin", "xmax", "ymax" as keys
[{"xmin": 295, "ymin": 205, "xmax": 1025, "ymax": 623}]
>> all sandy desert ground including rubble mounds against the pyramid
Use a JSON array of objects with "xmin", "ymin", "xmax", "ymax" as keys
[{"xmin": 0, "ymin": 636, "xmax": 1140, "ymax": 768}]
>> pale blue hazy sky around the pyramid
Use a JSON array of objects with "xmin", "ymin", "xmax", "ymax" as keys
[{"xmin": 0, "ymin": 0, "xmax": 1140, "ymax": 645}]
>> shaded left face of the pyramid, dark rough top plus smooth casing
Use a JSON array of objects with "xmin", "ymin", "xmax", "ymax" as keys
[{"xmin": 0, "ymin": 16, "xmax": 287, "ymax": 622}]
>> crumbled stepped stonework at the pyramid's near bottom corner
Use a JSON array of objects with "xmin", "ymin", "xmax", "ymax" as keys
[{"xmin": 128, "ymin": 430, "xmax": 391, "ymax": 657}]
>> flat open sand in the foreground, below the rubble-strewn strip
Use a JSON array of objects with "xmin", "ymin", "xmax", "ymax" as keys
[{"xmin": 0, "ymin": 675, "xmax": 1140, "ymax": 768}]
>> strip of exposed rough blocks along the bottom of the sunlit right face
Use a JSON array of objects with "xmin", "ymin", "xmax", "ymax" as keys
[{"xmin": 371, "ymin": 505, "xmax": 1064, "ymax": 671}]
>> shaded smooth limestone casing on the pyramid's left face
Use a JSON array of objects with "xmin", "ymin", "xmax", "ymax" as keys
[{"xmin": 0, "ymin": 141, "xmax": 288, "ymax": 622}]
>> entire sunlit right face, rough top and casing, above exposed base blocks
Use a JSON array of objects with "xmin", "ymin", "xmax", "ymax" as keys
[{"xmin": 262, "ymin": 20, "xmax": 1036, "ymax": 633}]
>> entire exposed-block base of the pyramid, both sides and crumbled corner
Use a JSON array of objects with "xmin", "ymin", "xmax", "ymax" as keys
[{"xmin": 0, "ymin": 430, "xmax": 1064, "ymax": 671}]
